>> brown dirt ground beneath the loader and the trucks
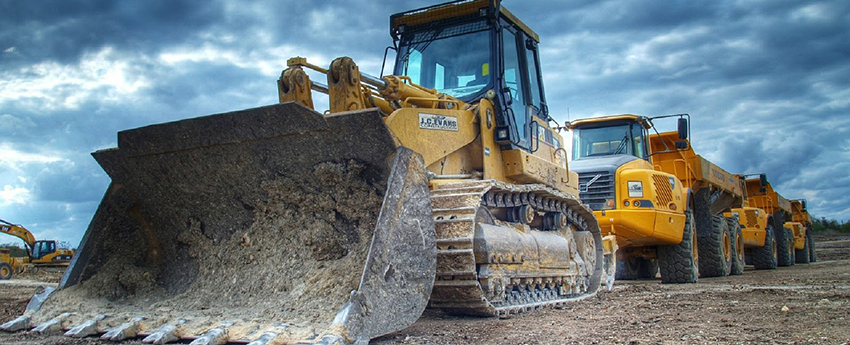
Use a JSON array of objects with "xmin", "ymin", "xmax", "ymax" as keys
[{"xmin": 0, "ymin": 235, "xmax": 850, "ymax": 345}]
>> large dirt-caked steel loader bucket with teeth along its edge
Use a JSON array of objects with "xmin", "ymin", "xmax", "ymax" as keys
[{"xmin": 17, "ymin": 103, "xmax": 437, "ymax": 344}]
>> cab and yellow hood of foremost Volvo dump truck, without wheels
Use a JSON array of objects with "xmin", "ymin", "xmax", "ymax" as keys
[{"xmin": 570, "ymin": 115, "xmax": 687, "ymax": 248}]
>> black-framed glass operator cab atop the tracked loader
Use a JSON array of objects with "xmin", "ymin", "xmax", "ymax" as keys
[{"xmin": 390, "ymin": 0, "xmax": 549, "ymax": 151}]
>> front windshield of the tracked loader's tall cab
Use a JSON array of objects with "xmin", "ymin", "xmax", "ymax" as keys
[{"xmin": 396, "ymin": 21, "xmax": 491, "ymax": 99}]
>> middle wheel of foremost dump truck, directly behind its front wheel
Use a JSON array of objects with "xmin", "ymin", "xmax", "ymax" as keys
[{"xmin": 697, "ymin": 216, "xmax": 734, "ymax": 277}]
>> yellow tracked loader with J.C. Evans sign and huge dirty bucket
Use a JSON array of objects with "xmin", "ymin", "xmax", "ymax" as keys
[{"xmin": 0, "ymin": 0, "xmax": 604, "ymax": 345}]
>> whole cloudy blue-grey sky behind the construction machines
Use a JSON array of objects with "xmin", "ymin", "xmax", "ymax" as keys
[{"xmin": 0, "ymin": 0, "xmax": 850, "ymax": 244}]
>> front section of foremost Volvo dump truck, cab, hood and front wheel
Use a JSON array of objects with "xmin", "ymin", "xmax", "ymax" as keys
[{"xmin": 568, "ymin": 114, "xmax": 699, "ymax": 283}]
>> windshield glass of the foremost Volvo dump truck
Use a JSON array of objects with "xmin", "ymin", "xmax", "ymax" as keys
[{"xmin": 573, "ymin": 124, "xmax": 644, "ymax": 159}]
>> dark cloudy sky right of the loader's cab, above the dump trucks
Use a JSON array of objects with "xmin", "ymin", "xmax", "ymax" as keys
[{"xmin": 506, "ymin": 1, "xmax": 850, "ymax": 219}]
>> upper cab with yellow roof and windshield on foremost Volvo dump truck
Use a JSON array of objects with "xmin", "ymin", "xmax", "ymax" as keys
[{"xmin": 570, "ymin": 115, "xmax": 648, "ymax": 161}]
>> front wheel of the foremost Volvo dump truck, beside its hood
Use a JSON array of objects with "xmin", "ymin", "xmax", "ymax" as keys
[{"xmin": 657, "ymin": 210, "xmax": 699, "ymax": 284}]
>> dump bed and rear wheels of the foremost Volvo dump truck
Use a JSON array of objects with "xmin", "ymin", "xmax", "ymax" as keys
[{"xmin": 649, "ymin": 127, "xmax": 744, "ymax": 277}]
